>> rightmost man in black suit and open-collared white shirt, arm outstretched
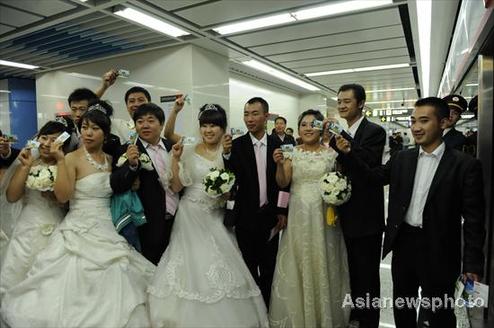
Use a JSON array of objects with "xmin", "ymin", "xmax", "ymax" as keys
[{"xmin": 337, "ymin": 97, "xmax": 485, "ymax": 328}]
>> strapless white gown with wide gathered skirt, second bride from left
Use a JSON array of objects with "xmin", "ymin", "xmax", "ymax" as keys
[{"xmin": 1, "ymin": 172, "xmax": 154, "ymax": 328}]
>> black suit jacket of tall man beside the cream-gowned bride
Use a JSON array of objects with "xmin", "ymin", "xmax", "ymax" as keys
[{"xmin": 330, "ymin": 118, "xmax": 386, "ymax": 238}]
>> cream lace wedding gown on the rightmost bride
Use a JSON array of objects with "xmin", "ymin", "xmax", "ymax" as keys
[{"xmin": 269, "ymin": 148, "xmax": 350, "ymax": 328}]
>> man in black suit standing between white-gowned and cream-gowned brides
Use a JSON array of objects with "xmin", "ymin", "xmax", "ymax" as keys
[{"xmin": 223, "ymin": 97, "xmax": 286, "ymax": 306}]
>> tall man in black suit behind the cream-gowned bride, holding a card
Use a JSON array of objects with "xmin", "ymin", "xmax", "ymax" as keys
[{"xmin": 329, "ymin": 84, "xmax": 386, "ymax": 328}]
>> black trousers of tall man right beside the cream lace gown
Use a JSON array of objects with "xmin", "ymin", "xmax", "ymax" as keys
[{"xmin": 345, "ymin": 233, "xmax": 382, "ymax": 328}]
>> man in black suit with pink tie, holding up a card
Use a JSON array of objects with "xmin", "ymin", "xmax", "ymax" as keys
[{"xmin": 110, "ymin": 103, "xmax": 178, "ymax": 264}]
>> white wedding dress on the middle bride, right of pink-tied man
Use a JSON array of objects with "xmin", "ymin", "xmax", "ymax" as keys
[{"xmin": 149, "ymin": 146, "xmax": 268, "ymax": 328}]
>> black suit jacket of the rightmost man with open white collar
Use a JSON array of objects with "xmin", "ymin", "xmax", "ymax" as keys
[{"xmin": 344, "ymin": 147, "xmax": 485, "ymax": 283}]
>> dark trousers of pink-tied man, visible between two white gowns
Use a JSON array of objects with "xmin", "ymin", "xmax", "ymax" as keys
[{"xmin": 138, "ymin": 218, "xmax": 175, "ymax": 265}]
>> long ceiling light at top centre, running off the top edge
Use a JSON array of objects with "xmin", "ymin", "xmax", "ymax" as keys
[{"xmin": 213, "ymin": 0, "xmax": 393, "ymax": 35}]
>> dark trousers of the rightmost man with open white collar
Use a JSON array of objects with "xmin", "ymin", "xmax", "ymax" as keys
[{"xmin": 391, "ymin": 223, "xmax": 456, "ymax": 328}]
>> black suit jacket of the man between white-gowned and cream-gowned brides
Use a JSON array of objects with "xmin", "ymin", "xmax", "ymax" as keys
[{"xmin": 225, "ymin": 133, "xmax": 286, "ymax": 231}]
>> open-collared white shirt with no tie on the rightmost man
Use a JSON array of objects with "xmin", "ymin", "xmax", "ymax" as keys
[{"xmin": 405, "ymin": 142, "xmax": 446, "ymax": 227}]
